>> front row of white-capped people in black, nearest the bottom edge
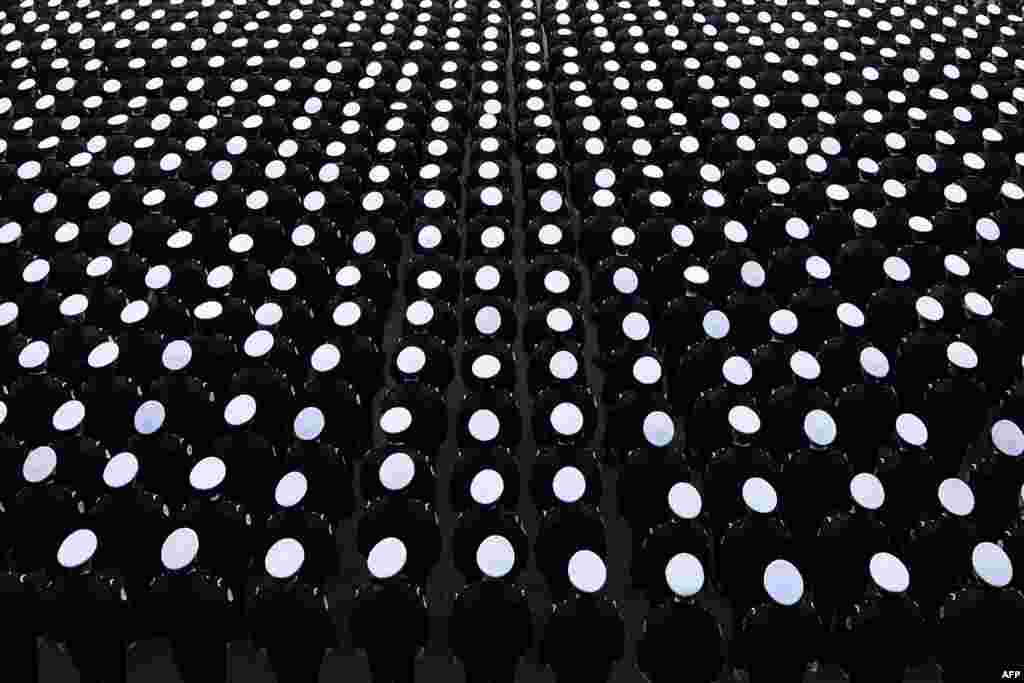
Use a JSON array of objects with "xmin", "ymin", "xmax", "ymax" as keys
[{"xmin": 0, "ymin": 527, "xmax": 1024, "ymax": 683}]
